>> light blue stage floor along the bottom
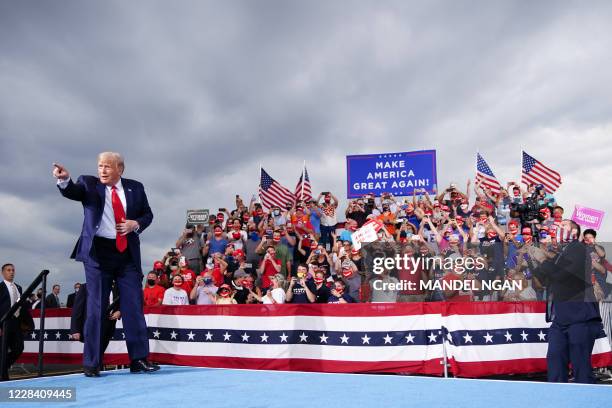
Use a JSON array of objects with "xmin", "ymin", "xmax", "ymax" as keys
[{"xmin": 0, "ymin": 366, "xmax": 612, "ymax": 408}]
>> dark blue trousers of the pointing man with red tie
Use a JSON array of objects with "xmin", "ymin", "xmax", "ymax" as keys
[{"xmin": 83, "ymin": 237, "xmax": 149, "ymax": 368}]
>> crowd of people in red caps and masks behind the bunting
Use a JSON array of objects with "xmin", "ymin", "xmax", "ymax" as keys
[{"xmin": 136, "ymin": 180, "xmax": 612, "ymax": 306}]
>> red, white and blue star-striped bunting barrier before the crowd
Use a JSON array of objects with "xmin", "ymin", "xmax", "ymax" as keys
[{"xmin": 20, "ymin": 302, "xmax": 612, "ymax": 377}]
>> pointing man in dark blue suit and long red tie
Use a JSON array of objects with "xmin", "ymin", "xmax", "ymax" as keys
[{"xmin": 53, "ymin": 152, "xmax": 159, "ymax": 377}]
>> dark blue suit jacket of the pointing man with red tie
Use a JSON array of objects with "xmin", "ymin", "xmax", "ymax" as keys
[{"xmin": 58, "ymin": 176, "xmax": 153, "ymax": 273}]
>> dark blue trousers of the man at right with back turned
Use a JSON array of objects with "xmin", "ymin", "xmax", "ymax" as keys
[{"xmin": 546, "ymin": 321, "xmax": 601, "ymax": 384}]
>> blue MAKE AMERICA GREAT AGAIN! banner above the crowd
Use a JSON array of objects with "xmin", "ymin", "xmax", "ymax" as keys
[{"xmin": 346, "ymin": 150, "xmax": 438, "ymax": 198}]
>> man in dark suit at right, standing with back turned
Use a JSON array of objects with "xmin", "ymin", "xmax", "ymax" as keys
[{"xmin": 535, "ymin": 221, "xmax": 603, "ymax": 384}]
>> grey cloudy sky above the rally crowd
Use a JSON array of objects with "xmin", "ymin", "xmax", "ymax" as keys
[{"xmin": 0, "ymin": 0, "xmax": 612, "ymax": 295}]
